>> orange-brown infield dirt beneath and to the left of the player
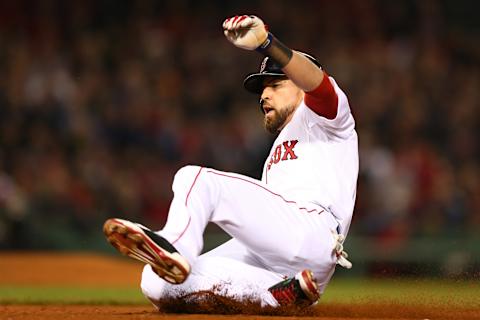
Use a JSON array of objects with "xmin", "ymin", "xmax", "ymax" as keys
[{"xmin": 0, "ymin": 253, "xmax": 480, "ymax": 320}]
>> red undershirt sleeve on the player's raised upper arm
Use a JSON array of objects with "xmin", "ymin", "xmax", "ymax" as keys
[{"xmin": 305, "ymin": 72, "xmax": 338, "ymax": 120}]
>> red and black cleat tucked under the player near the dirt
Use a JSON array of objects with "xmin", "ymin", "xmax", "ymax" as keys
[{"xmin": 268, "ymin": 270, "xmax": 320, "ymax": 306}]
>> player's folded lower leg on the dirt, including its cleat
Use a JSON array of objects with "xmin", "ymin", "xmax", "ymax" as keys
[{"xmin": 141, "ymin": 239, "xmax": 320, "ymax": 308}]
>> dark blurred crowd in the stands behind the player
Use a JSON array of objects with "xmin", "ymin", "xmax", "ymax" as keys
[{"xmin": 0, "ymin": 0, "xmax": 480, "ymax": 249}]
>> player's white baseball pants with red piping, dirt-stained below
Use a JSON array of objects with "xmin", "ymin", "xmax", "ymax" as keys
[{"xmin": 141, "ymin": 166, "xmax": 338, "ymax": 305}]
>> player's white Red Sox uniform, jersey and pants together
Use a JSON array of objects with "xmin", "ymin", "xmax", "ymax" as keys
[{"xmin": 141, "ymin": 78, "xmax": 358, "ymax": 305}]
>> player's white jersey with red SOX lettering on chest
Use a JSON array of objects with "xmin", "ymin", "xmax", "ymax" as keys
[{"xmin": 262, "ymin": 77, "xmax": 358, "ymax": 235}]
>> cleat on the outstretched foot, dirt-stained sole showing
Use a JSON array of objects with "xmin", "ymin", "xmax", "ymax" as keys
[{"xmin": 103, "ymin": 218, "xmax": 190, "ymax": 284}]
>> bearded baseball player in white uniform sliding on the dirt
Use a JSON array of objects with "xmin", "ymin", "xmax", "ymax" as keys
[{"xmin": 104, "ymin": 15, "xmax": 358, "ymax": 306}]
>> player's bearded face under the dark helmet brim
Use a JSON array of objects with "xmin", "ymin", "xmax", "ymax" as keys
[{"xmin": 261, "ymin": 77, "xmax": 303, "ymax": 133}]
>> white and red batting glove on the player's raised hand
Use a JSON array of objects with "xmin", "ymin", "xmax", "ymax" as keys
[{"xmin": 223, "ymin": 15, "xmax": 268, "ymax": 50}]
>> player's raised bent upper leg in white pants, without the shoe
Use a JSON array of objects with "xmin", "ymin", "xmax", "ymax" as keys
[{"xmin": 159, "ymin": 166, "xmax": 338, "ymax": 278}]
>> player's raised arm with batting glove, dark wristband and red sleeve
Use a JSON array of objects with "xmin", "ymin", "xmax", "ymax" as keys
[{"xmin": 223, "ymin": 15, "xmax": 338, "ymax": 119}]
